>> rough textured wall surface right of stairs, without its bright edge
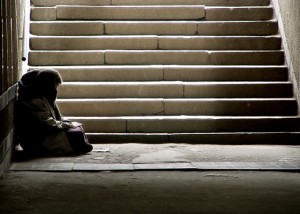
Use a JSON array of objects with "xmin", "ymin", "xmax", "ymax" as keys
[{"xmin": 275, "ymin": 0, "xmax": 300, "ymax": 88}]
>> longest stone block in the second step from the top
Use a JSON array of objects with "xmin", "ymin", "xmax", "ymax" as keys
[{"xmin": 56, "ymin": 5, "xmax": 205, "ymax": 19}]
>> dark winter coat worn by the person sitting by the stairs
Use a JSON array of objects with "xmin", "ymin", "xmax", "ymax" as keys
[{"xmin": 17, "ymin": 97, "xmax": 73, "ymax": 154}]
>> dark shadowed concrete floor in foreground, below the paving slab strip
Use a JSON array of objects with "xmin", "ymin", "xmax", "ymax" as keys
[{"xmin": 0, "ymin": 171, "xmax": 300, "ymax": 214}]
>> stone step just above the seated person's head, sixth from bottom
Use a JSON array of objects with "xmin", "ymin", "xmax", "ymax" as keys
[{"xmin": 29, "ymin": 50, "xmax": 284, "ymax": 66}]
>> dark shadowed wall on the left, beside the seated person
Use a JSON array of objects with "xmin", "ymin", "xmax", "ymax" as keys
[{"xmin": 0, "ymin": 0, "xmax": 25, "ymax": 177}]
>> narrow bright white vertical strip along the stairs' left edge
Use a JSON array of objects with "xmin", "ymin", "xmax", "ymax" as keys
[{"xmin": 22, "ymin": 0, "xmax": 30, "ymax": 74}]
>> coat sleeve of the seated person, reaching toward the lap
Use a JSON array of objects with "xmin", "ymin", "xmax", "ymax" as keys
[{"xmin": 24, "ymin": 99, "xmax": 72, "ymax": 129}]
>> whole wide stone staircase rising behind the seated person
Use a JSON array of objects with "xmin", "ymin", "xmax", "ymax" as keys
[{"xmin": 29, "ymin": 0, "xmax": 300, "ymax": 144}]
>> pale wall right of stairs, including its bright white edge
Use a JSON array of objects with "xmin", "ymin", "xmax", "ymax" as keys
[{"xmin": 272, "ymin": 0, "xmax": 300, "ymax": 107}]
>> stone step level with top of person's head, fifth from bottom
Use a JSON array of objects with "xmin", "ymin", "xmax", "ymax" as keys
[{"xmin": 30, "ymin": 65, "xmax": 289, "ymax": 82}]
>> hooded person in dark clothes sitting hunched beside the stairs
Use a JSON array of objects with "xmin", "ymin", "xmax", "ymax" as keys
[{"xmin": 17, "ymin": 69, "xmax": 93, "ymax": 155}]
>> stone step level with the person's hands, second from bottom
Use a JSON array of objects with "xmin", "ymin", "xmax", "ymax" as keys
[{"xmin": 63, "ymin": 115, "xmax": 300, "ymax": 134}]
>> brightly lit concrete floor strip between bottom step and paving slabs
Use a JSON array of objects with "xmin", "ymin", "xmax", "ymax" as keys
[{"xmin": 11, "ymin": 143, "xmax": 300, "ymax": 164}]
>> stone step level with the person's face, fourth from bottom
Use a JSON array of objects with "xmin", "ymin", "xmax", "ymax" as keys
[{"xmin": 59, "ymin": 81, "xmax": 293, "ymax": 98}]
